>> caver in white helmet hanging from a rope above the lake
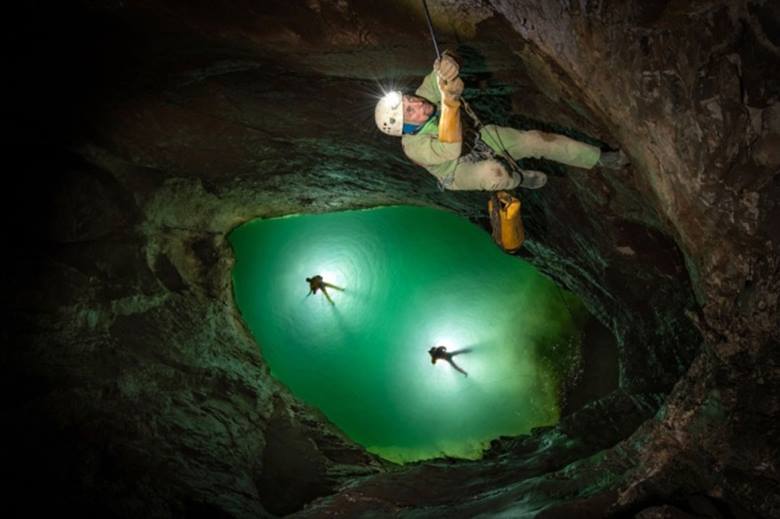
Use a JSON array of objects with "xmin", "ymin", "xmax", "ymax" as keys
[{"xmin": 374, "ymin": 51, "xmax": 628, "ymax": 191}]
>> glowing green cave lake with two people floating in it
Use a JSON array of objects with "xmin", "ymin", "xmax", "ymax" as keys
[{"xmin": 229, "ymin": 206, "xmax": 589, "ymax": 463}]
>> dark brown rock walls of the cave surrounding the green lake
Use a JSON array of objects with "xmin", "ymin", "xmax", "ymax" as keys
[{"xmin": 2, "ymin": 0, "xmax": 780, "ymax": 517}]
